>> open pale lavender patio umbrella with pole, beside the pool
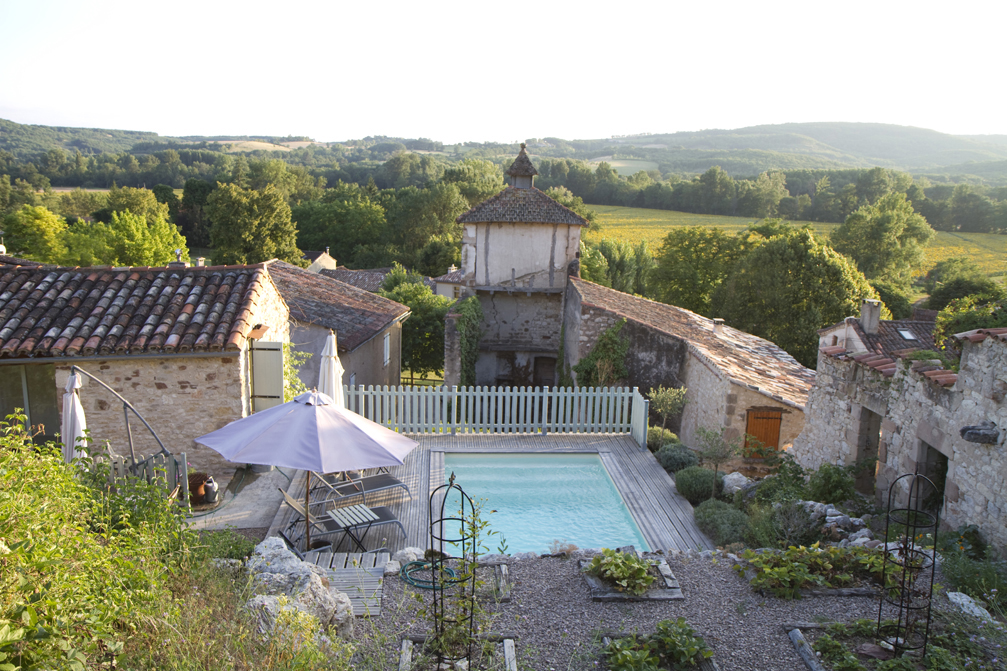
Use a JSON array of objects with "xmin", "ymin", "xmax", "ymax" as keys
[{"xmin": 195, "ymin": 392, "xmax": 418, "ymax": 547}]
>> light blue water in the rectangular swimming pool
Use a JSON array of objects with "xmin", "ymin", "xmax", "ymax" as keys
[{"xmin": 444, "ymin": 452, "xmax": 650, "ymax": 554}]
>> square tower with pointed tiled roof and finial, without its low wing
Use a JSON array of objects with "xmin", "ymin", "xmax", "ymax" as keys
[{"xmin": 444, "ymin": 145, "xmax": 587, "ymax": 387}]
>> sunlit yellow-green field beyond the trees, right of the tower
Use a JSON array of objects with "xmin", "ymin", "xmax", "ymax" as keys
[{"xmin": 586, "ymin": 206, "xmax": 1007, "ymax": 276}]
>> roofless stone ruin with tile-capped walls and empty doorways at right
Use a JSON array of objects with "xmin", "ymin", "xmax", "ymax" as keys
[{"xmin": 792, "ymin": 328, "xmax": 1007, "ymax": 547}]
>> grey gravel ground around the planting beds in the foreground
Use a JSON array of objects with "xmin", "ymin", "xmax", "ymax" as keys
[{"xmin": 357, "ymin": 556, "xmax": 906, "ymax": 671}]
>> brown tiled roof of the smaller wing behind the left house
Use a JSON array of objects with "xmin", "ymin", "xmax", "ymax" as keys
[{"xmin": 267, "ymin": 261, "xmax": 409, "ymax": 352}]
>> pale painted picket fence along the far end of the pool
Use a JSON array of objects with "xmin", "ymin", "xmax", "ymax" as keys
[{"xmin": 343, "ymin": 386, "xmax": 650, "ymax": 445}]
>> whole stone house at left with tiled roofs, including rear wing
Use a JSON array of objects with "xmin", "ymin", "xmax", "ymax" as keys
[{"xmin": 0, "ymin": 255, "xmax": 408, "ymax": 486}]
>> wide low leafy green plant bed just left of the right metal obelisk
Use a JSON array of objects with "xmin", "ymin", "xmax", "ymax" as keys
[{"xmin": 734, "ymin": 543, "xmax": 900, "ymax": 598}]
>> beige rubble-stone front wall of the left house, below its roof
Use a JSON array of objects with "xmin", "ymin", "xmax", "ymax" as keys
[{"xmin": 55, "ymin": 352, "xmax": 248, "ymax": 487}]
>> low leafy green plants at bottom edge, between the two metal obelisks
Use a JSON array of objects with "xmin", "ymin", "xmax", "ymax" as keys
[{"xmin": 605, "ymin": 618, "xmax": 713, "ymax": 671}]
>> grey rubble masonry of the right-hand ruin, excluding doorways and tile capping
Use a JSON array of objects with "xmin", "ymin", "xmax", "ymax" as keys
[{"xmin": 793, "ymin": 338, "xmax": 1007, "ymax": 548}]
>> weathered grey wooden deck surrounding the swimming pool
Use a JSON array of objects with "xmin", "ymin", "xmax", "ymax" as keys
[{"xmin": 269, "ymin": 433, "xmax": 714, "ymax": 552}]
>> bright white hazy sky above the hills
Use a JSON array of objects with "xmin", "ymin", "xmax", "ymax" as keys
[{"xmin": 0, "ymin": 0, "xmax": 1007, "ymax": 142}]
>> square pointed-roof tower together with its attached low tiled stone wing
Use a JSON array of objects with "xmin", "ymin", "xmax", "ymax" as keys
[{"xmin": 444, "ymin": 147, "xmax": 815, "ymax": 447}]
